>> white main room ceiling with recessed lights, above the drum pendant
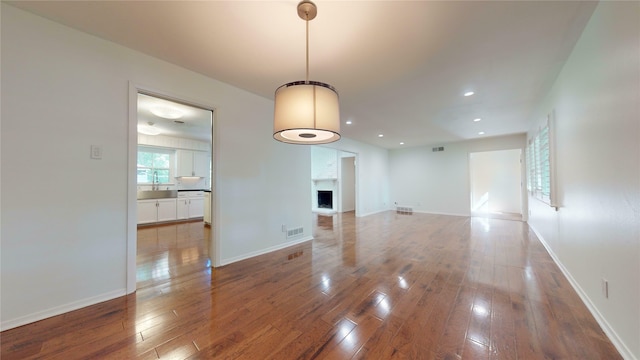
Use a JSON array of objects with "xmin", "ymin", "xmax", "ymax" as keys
[{"xmin": 10, "ymin": 0, "xmax": 596, "ymax": 148}]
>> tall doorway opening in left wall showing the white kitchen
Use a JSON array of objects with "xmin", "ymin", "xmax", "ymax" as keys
[{"xmin": 127, "ymin": 87, "xmax": 216, "ymax": 293}]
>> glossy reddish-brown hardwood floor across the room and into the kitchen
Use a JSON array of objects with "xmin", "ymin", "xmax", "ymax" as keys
[{"xmin": 1, "ymin": 212, "xmax": 621, "ymax": 360}]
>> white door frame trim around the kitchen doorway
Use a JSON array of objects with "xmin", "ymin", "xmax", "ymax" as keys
[{"xmin": 126, "ymin": 81, "xmax": 220, "ymax": 294}]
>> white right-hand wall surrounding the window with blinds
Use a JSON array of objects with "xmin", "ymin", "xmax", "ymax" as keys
[{"xmin": 529, "ymin": 2, "xmax": 640, "ymax": 359}]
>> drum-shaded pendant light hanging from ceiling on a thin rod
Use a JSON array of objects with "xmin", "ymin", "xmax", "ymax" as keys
[{"xmin": 273, "ymin": 0, "xmax": 340, "ymax": 145}]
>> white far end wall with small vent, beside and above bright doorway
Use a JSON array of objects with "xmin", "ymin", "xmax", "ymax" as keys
[{"xmin": 389, "ymin": 134, "xmax": 525, "ymax": 216}]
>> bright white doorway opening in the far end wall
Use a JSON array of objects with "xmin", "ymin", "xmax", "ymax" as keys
[{"xmin": 469, "ymin": 149, "xmax": 523, "ymax": 221}]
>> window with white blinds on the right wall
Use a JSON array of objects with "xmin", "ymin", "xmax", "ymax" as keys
[{"xmin": 526, "ymin": 116, "xmax": 555, "ymax": 206}]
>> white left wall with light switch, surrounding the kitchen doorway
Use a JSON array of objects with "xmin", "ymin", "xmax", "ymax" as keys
[{"xmin": 0, "ymin": 3, "xmax": 311, "ymax": 329}]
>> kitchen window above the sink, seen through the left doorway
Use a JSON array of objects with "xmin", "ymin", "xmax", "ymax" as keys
[{"xmin": 137, "ymin": 146, "xmax": 175, "ymax": 184}]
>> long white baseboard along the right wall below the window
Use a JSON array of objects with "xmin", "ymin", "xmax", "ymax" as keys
[{"xmin": 528, "ymin": 223, "xmax": 638, "ymax": 360}]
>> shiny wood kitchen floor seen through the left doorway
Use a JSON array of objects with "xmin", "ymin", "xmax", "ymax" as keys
[{"xmin": 137, "ymin": 221, "xmax": 211, "ymax": 289}]
